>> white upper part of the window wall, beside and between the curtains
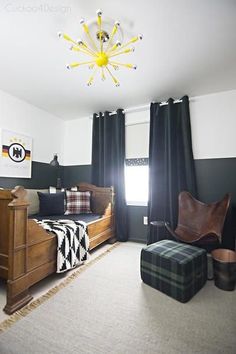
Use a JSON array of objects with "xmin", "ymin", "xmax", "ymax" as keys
[{"xmin": 64, "ymin": 90, "xmax": 236, "ymax": 165}]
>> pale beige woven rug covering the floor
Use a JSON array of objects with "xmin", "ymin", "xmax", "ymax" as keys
[{"xmin": 0, "ymin": 242, "xmax": 236, "ymax": 354}]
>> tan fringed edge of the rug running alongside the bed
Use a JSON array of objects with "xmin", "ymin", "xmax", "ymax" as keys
[{"xmin": 0, "ymin": 242, "xmax": 120, "ymax": 333}]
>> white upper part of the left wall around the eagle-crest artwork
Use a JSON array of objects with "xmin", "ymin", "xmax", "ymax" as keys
[{"xmin": 0, "ymin": 91, "xmax": 64, "ymax": 164}]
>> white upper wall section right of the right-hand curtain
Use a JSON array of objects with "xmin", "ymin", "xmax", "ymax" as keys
[{"xmin": 190, "ymin": 90, "xmax": 236, "ymax": 159}]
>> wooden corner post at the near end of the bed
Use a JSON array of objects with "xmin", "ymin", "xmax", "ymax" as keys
[{"xmin": 4, "ymin": 187, "xmax": 33, "ymax": 314}]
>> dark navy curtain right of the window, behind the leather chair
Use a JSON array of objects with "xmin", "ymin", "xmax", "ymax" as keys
[{"xmin": 148, "ymin": 96, "xmax": 197, "ymax": 244}]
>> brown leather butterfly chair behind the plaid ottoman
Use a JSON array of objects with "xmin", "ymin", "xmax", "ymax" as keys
[{"xmin": 165, "ymin": 191, "xmax": 230, "ymax": 252}]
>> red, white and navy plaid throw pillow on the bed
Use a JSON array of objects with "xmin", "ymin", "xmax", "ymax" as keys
[{"xmin": 65, "ymin": 191, "xmax": 91, "ymax": 215}]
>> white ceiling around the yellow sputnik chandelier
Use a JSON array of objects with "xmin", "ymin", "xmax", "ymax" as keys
[{"xmin": 0, "ymin": 0, "xmax": 236, "ymax": 120}]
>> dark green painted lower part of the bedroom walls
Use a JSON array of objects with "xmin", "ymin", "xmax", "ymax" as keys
[{"xmin": 0, "ymin": 158, "xmax": 236, "ymax": 248}]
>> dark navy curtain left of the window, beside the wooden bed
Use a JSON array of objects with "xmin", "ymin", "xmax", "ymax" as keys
[{"xmin": 92, "ymin": 109, "xmax": 128, "ymax": 241}]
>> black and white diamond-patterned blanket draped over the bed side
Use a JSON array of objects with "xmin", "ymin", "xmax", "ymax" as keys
[{"xmin": 35, "ymin": 219, "xmax": 89, "ymax": 273}]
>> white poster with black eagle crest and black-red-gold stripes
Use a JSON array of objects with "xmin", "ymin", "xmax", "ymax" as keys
[{"xmin": 0, "ymin": 129, "xmax": 32, "ymax": 178}]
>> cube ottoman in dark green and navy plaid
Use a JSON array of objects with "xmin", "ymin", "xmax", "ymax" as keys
[{"xmin": 141, "ymin": 240, "xmax": 207, "ymax": 302}]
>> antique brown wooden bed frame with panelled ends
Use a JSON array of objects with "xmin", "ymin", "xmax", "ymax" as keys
[{"xmin": 0, "ymin": 183, "xmax": 115, "ymax": 314}]
